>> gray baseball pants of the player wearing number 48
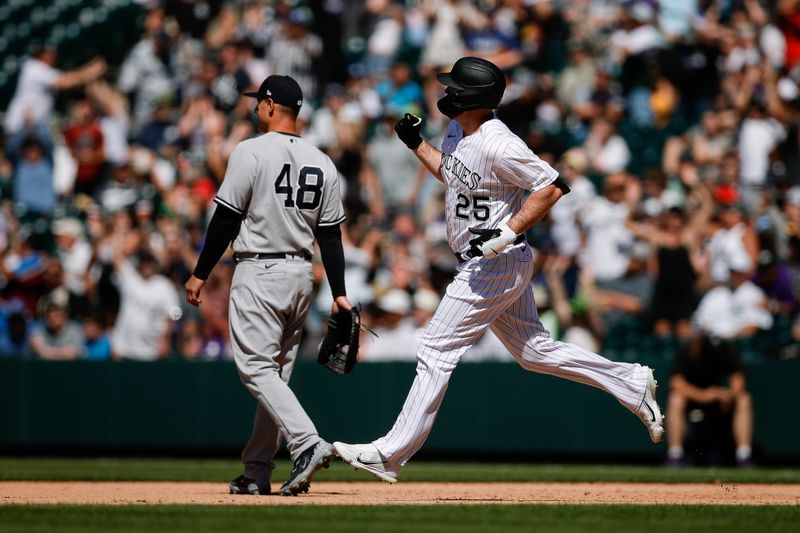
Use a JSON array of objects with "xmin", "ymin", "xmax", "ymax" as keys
[{"xmin": 229, "ymin": 259, "xmax": 319, "ymax": 480}]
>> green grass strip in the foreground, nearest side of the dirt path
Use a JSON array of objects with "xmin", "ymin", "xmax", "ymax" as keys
[{"xmin": 0, "ymin": 505, "xmax": 800, "ymax": 533}]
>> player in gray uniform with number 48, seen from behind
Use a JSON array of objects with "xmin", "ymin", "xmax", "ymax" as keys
[{"xmin": 186, "ymin": 76, "xmax": 351, "ymax": 495}]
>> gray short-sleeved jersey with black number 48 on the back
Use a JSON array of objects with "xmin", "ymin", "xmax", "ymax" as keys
[{"xmin": 215, "ymin": 132, "xmax": 345, "ymax": 255}]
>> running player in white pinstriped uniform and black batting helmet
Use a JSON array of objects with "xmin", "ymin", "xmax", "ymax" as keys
[{"xmin": 333, "ymin": 57, "xmax": 664, "ymax": 482}]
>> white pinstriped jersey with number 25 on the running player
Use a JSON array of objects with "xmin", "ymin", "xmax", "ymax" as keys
[{"xmin": 440, "ymin": 118, "xmax": 558, "ymax": 253}]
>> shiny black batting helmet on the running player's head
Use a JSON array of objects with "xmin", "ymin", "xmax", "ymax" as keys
[{"xmin": 436, "ymin": 57, "xmax": 506, "ymax": 112}]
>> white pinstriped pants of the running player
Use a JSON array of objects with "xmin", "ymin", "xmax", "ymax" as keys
[{"xmin": 373, "ymin": 243, "xmax": 648, "ymax": 465}]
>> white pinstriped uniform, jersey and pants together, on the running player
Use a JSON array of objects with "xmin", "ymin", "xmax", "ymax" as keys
[{"xmin": 368, "ymin": 119, "xmax": 663, "ymax": 468}]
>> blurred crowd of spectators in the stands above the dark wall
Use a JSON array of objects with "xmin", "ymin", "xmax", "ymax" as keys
[{"xmin": 0, "ymin": 0, "xmax": 800, "ymax": 361}]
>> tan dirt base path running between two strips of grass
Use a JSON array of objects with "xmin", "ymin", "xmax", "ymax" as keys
[{"xmin": 6, "ymin": 481, "xmax": 800, "ymax": 505}]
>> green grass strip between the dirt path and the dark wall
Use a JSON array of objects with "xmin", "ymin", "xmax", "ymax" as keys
[{"xmin": 0, "ymin": 457, "xmax": 800, "ymax": 483}]
